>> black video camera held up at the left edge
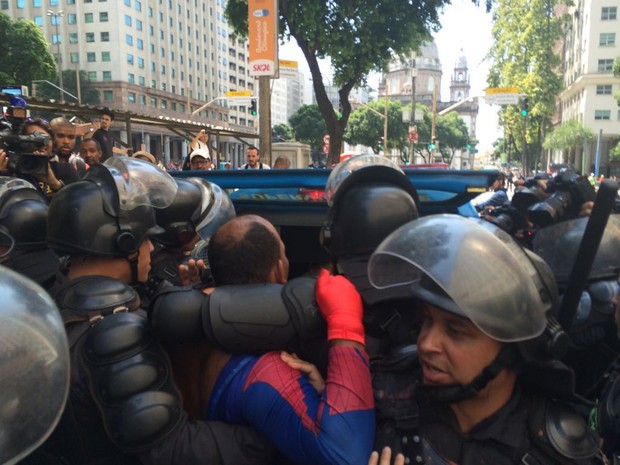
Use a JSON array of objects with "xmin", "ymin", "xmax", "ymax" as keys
[{"xmin": 0, "ymin": 118, "xmax": 50, "ymax": 175}]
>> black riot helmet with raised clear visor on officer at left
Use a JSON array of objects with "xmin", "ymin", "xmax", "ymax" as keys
[{"xmin": 47, "ymin": 157, "xmax": 177, "ymax": 257}]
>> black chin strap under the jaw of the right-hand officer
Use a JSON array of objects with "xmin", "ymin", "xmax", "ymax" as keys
[{"xmin": 421, "ymin": 344, "xmax": 517, "ymax": 404}]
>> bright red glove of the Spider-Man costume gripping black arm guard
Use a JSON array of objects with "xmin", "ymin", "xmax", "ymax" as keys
[{"xmin": 316, "ymin": 269, "xmax": 364, "ymax": 344}]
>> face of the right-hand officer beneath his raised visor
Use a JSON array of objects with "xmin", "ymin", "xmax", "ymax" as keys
[{"xmin": 418, "ymin": 303, "xmax": 502, "ymax": 385}]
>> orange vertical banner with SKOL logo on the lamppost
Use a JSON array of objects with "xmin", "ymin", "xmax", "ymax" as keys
[{"xmin": 248, "ymin": 0, "xmax": 278, "ymax": 76}]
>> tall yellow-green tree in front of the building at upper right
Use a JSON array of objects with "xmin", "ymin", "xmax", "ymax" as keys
[{"xmin": 488, "ymin": 0, "xmax": 563, "ymax": 172}]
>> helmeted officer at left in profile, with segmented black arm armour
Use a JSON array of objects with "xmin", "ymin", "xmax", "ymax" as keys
[{"xmin": 41, "ymin": 157, "xmax": 271, "ymax": 464}]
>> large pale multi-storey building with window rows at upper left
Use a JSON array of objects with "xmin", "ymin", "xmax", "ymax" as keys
[{"xmin": 0, "ymin": 0, "xmax": 258, "ymax": 165}]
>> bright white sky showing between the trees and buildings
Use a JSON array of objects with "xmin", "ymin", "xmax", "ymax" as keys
[{"xmin": 280, "ymin": 0, "xmax": 501, "ymax": 153}]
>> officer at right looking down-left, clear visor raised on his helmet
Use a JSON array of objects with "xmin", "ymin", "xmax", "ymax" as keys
[{"xmin": 368, "ymin": 215, "xmax": 602, "ymax": 465}]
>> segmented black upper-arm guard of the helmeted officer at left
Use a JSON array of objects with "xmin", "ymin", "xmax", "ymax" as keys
[{"xmin": 80, "ymin": 312, "xmax": 183, "ymax": 453}]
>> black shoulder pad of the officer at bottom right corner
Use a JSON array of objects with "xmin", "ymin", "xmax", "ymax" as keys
[{"xmin": 533, "ymin": 400, "xmax": 599, "ymax": 462}]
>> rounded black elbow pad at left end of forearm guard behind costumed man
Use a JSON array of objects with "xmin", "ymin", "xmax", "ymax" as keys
[{"xmin": 149, "ymin": 287, "xmax": 209, "ymax": 343}]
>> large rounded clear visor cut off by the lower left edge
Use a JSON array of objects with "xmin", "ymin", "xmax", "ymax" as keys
[{"xmin": 0, "ymin": 266, "xmax": 69, "ymax": 463}]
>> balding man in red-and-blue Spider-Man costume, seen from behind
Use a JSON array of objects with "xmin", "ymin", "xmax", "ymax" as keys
[{"xmin": 151, "ymin": 215, "xmax": 374, "ymax": 465}]
